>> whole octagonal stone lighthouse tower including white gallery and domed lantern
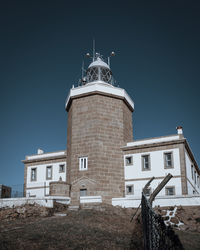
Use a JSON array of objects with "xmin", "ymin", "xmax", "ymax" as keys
[{"xmin": 66, "ymin": 53, "xmax": 134, "ymax": 205}]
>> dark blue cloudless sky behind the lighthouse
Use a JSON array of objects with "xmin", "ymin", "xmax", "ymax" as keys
[{"xmin": 0, "ymin": 0, "xmax": 200, "ymax": 185}]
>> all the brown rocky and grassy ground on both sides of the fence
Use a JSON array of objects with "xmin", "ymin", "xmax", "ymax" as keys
[{"xmin": 0, "ymin": 205, "xmax": 200, "ymax": 250}]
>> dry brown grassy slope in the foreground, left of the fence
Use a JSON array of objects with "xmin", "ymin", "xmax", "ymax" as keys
[{"xmin": 0, "ymin": 205, "xmax": 143, "ymax": 250}]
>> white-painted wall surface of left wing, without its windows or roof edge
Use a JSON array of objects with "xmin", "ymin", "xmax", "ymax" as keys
[{"xmin": 26, "ymin": 161, "xmax": 67, "ymax": 197}]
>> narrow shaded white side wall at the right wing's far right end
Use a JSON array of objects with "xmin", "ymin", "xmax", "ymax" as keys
[{"xmin": 185, "ymin": 151, "xmax": 200, "ymax": 194}]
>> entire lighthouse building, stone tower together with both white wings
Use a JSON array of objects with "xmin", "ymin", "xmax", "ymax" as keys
[{"xmin": 23, "ymin": 53, "xmax": 200, "ymax": 205}]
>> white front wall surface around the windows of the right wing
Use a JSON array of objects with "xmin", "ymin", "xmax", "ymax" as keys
[{"xmin": 124, "ymin": 148, "xmax": 181, "ymax": 197}]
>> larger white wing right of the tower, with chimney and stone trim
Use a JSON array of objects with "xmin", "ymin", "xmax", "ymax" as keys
[{"xmin": 122, "ymin": 127, "xmax": 200, "ymax": 197}]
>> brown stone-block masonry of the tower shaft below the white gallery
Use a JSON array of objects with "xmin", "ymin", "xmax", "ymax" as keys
[{"xmin": 67, "ymin": 94, "xmax": 133, "ymax": 204}]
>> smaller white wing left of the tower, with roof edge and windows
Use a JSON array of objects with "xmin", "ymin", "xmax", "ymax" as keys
[{"xmin": 23, "ymin": 149, "xmax": 67, "ymax": 197}]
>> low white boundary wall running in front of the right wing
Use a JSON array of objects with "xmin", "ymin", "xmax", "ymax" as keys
[{"xmin": 112, "ymin": 195, "xmax": 200, "ymax": 208}]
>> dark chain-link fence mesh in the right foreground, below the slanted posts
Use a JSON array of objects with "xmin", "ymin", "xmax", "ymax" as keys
[{"xmin": 142, "ymin": 194, "xmax": 183, "ymax": 250}]
